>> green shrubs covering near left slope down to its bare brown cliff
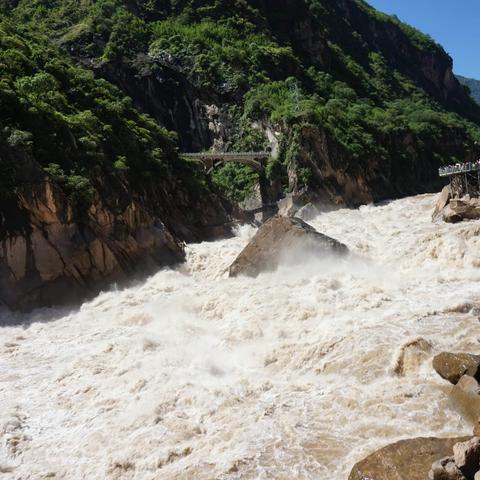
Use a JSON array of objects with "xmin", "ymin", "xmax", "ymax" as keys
[{"xmin": 0, "ymin": 5, "xmax": 229, "ymax": 240}]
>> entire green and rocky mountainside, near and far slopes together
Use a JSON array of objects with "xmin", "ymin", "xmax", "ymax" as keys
[{"xmin": 0, "ymin": 0, "xmax": 480, "ymax": 304}]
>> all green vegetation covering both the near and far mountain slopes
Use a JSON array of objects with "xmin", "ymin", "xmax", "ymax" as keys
[{"xmin": 4, "ymin": 0, "xmax": 480, "ymax": 199}]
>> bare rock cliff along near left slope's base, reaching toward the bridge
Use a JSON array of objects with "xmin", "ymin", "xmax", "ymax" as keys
[{"xmin": 0, "ymin": 146, "xmax": 229, "ymax": 309}]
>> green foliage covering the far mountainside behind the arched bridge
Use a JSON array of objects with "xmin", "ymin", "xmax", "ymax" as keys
[{"xmin": 9, "ymin": 0, "xmax": 480, "ymax": 201}]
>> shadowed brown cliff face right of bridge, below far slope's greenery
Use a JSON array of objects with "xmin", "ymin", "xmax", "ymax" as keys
[{"xmin": 289, "ymin": 127, "xmax": 475, "ymax": 206}]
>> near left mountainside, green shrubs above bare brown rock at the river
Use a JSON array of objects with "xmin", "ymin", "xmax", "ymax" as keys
[{"xmin": 0, "ymin": 11, "xmax": 231, "ymax": 308}]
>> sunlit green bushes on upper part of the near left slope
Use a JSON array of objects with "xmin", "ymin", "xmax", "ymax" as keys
[{"xmin": 0, "ymin": 10, "xmax": 179, "ymax": 212}]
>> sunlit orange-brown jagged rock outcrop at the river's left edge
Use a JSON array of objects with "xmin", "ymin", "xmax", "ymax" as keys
[{"xmin": 0, "ymin": 180, "xmax": 185, "ymax": 309}]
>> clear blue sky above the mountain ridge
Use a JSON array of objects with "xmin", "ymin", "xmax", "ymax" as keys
[{"xmin": 367, "ymin": 0, "xmax": 480, "ymax": 80}]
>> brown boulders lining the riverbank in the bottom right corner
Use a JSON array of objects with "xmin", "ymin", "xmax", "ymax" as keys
[{"xmin": 349, "ymin": 352, "xmax": 480, "ymax": 480}]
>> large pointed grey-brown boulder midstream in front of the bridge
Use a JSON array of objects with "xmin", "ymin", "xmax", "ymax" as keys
[{"xmin": 230, "ymin": 215, "xmax": 348, "ymax": 277}]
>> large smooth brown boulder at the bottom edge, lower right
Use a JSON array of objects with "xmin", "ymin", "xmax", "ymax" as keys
[{"xmin": 348, "ymin": 437, "xmax": 468, "ymax": 480}]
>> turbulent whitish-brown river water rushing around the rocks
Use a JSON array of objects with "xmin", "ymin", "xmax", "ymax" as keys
[{"xmin": 0, "ymin": 195, "xmax": 480, "ymax": 480}]
